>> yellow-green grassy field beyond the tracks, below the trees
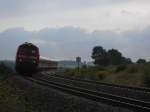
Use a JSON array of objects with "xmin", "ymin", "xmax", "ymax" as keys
[{"xmin": 65, "ymin": 63, "xmax": 150, "ymax": 87}]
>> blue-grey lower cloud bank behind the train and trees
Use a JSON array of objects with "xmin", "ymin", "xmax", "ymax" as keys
[{"xmin": 0, "ymin": 27, "xmax": 150, "ymax": 61}]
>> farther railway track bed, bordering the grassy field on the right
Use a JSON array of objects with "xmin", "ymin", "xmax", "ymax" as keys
[{"xmin": 40, "ymin": 72, "xmax": 150, "ymax": 102}]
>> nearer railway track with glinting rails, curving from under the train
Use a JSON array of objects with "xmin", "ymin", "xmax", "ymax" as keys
[{"xmin": 24, "ymin": 73, "xmax": 150, "ymax": 112}]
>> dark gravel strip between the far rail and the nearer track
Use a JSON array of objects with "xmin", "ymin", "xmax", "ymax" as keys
[{"xmin": 42, "ymin": 74, "xmax": 150, "ymax": 102}]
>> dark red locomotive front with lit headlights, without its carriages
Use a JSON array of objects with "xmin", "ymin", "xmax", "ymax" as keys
[{"xmin": 16, "ymin": 42, "xmax": 39, "ymax": 73}]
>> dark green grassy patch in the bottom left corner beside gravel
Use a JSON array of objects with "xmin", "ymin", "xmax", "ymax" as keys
[{"xmin": 0, "ymin": 65, "xmax": 32, "ymax": 112}]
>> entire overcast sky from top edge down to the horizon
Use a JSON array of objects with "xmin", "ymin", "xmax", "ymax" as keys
[{"xmin": 0, "ymin": 0, "xmax": 150, "ymax": 60}]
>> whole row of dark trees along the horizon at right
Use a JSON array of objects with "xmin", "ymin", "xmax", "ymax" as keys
[{"xmin": 91, "ymin": 46, "xmax": 146, "ymax": 66}]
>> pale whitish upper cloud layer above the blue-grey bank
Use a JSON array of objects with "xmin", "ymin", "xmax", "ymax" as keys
[{"xmin": 0, "ymin": 0, "xmax": 150, "ymax": 31}]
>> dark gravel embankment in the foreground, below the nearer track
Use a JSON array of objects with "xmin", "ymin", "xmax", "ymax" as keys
[{"xmin": 8, "ymin": 75, "xmax": 133, "ymax": 112}]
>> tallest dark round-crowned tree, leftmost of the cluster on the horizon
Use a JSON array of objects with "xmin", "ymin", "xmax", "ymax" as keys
[{"xmin": 91, "ymin": 46, "xmax": 108, "ymax": 66}]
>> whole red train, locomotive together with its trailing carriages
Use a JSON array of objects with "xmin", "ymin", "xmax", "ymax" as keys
[{"xmin": 15, "ymin": 42, "xmax": 58, "ymax": 75}]
